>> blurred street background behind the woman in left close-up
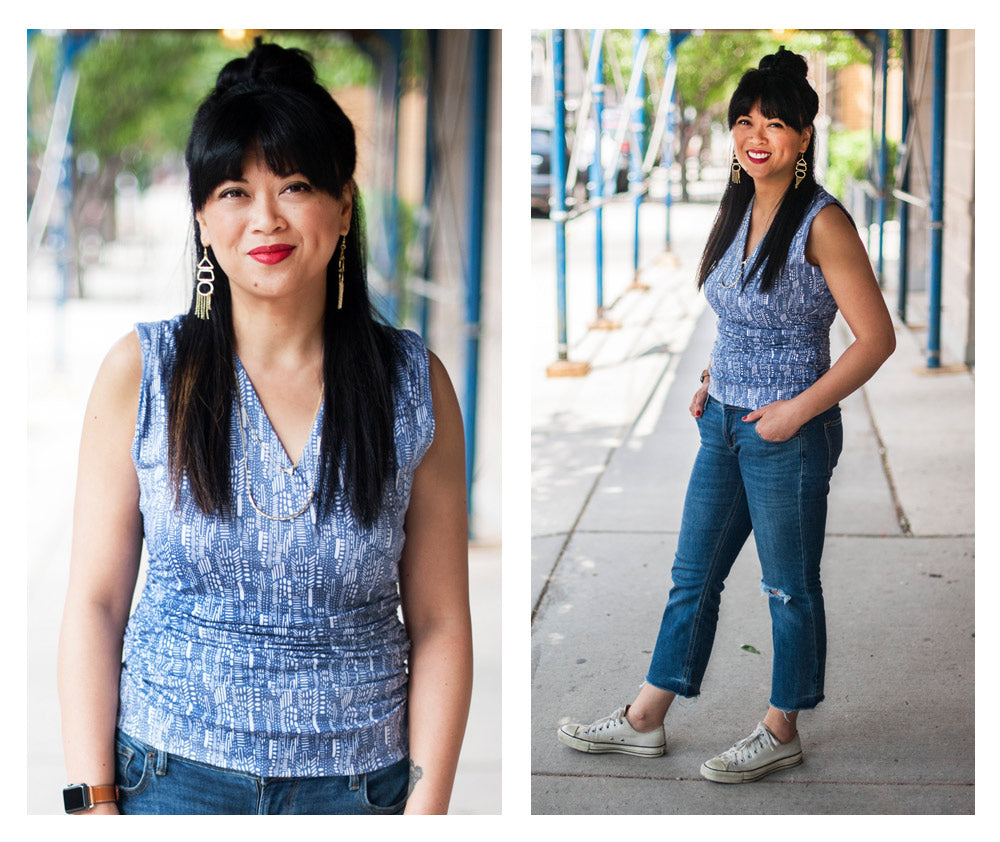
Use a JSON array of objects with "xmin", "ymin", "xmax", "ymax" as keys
[{"xmin": 26, "ymin": 30, "xmax": 501, "ymax": 813}]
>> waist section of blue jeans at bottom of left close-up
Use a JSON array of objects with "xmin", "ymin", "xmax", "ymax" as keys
[{"xmin": 115, "ymin": 731, "xmax": 410, "ymax": 815}]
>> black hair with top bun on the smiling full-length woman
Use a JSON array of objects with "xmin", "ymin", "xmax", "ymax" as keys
[{"xmin": 698, "ymin": 47, "xmax": 819, "ymax": 292}]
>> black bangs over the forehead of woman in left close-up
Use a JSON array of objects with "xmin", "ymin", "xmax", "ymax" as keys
[{"xmin": 186, "ymin": 91, "xmax": 354, "ymax": 210}]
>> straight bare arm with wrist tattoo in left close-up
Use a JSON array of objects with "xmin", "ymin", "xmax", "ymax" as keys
[{"xmin": 400, "ymin": 354, "xmax": 472, "ymax": 814}]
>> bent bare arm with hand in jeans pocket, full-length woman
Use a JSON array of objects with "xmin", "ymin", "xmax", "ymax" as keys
[{"xmin": 744, "ymin": 205, "xmax": 896, "ymax": 441}]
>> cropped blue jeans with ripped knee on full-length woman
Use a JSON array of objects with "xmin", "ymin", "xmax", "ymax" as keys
[{"xmin": 646, "ymin": 398, "xmax": 843, "ymax": 711}]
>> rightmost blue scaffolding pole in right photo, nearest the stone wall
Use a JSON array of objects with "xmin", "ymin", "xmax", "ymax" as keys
[{"xmin": 927, "ymin": 29, "xmax": 948, "ymax": 368}]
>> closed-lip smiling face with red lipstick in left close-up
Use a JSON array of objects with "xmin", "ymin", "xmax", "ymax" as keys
[{"xmin": 195, "ymin": 152, "xmax": 351, "ymax": 308}]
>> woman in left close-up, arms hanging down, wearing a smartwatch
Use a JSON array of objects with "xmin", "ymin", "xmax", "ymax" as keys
[{"xmin": 59, "ymin": 40, "xmax": 472, "ymax": 814}]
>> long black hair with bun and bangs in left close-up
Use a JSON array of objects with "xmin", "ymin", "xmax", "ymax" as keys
[{"xmin": 168, "ymin": 38, "xmax": 401, "ymax": 525}]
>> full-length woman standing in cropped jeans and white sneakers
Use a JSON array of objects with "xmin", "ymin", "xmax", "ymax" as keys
[{"xmin": 558, "ymin": 48, "xmax": 895, "ymax": 783}]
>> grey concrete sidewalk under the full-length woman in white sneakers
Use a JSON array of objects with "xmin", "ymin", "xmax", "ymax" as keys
[{"xmin": 532, "ymin": 197, "xmax": 975, "ymax": 814}]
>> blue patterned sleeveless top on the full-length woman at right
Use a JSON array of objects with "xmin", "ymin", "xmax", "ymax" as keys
[{"xmin": 704, "ymin": 188, "xmax": 839, "ymax": 409}]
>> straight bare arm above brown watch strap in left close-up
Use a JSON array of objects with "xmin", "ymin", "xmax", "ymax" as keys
[{"xmin": 59, "ymin": 333, "xmax": 142, "ymax": 813}]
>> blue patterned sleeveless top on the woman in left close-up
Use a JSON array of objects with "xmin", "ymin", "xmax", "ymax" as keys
[{"xmin": 118, "ymin": 316, "xmax": 434, "ymax": 777}]
